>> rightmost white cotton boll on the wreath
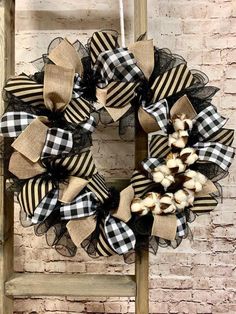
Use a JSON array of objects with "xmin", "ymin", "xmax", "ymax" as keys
[{"xmin": 183, "ymin": 169, "xmax": 207, "ymax": 192}]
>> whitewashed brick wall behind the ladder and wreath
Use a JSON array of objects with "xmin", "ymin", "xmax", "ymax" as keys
[{"xmin": 15, "ymin": 0, "xmax": 236, "ymax": 314}]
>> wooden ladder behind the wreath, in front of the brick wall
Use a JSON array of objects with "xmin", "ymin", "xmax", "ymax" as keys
[{"xmin": 0, "ymin": 0, "xmax": 149, "ymax": 314}]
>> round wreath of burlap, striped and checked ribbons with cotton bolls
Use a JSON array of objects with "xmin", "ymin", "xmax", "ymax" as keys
[{"xmin": 0, "ymin": 31, "xmax": 234, "ymax": 262}]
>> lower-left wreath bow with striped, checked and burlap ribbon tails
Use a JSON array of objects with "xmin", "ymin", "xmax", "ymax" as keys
[{"xmin": 15, "ymin": 151, "xmax": 109, "ymax": 223}]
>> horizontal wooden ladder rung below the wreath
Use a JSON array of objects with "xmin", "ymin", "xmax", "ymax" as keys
[{"xmin": 5, "ymin": 273, "xmax": 136, "ymax": 297}]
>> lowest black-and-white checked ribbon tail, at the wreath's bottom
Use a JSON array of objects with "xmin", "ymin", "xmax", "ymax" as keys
[{"xmin": 104, "ymin": 215, "xmax": 136, "ymax": 255}]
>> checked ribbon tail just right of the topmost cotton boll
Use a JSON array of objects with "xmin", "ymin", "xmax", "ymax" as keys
[{"xmin": 193, "ymin": 106, "xmax": 227, "ymax": 140}]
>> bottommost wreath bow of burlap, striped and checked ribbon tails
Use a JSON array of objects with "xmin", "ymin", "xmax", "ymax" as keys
[{"xmin": 67, "ymin": 186, "xmax": 136, "ymax": 256}]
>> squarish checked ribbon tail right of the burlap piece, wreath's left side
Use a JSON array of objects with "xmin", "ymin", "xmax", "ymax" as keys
[{"xmin": 41, "ymin": 128, "xmax": 73, "ymax": 159}]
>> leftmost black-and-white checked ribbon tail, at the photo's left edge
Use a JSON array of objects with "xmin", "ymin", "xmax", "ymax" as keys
[{"xmin": 0, "ymin": 111, "xmax": 37, "ymax": 137}]
